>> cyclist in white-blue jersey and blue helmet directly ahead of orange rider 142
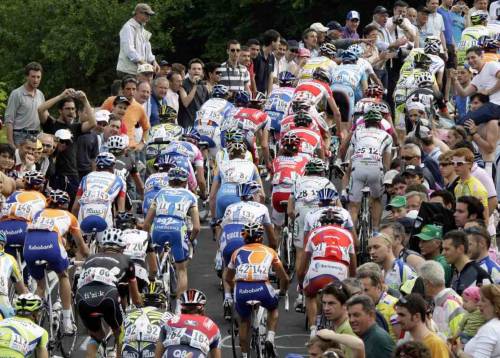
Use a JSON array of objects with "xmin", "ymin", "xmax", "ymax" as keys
[{"xmin": 219, "ymin": 181, "xmax": 276, "ymax": 320}]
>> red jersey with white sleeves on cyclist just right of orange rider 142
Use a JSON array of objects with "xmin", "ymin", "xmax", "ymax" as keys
[{"xmin": 304, "ymin": 225, "xmax": 355, "ymax": 265}]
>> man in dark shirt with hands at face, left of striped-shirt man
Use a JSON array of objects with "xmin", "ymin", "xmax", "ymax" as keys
[{"xmin": 177, "ymin": 58, "xmax": 209, "ymax": 128}]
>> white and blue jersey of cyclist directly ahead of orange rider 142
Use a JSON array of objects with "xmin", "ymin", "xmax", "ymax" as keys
[{"xmin": 221, "ymin": 201, "xmax": 271, "ymax": 228}]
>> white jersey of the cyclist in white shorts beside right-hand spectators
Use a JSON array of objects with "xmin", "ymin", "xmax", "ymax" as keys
[{"xmin": 350, "ymin": 127, "xmax": 392, "ymax": 166}]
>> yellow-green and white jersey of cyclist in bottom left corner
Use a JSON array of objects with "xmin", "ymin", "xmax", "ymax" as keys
[{"xmin": 0, "ymin": 316, "xmax": 49, "ymax": 358}]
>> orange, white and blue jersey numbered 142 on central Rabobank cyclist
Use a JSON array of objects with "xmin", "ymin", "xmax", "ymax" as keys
[{"xmin": 228, "ymin": 243, "xmax": 280, "ymax": 282}]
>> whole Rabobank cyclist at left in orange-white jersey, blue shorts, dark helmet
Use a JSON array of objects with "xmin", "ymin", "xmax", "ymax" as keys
[{"xmin": 24, "ymin": 190, "xmax": 89, "ymax": 334}]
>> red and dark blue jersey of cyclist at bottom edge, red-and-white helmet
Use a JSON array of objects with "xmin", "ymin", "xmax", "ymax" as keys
[{"xmin": 159, "ymin": 313, "xmax": 221, "ymax": 358}]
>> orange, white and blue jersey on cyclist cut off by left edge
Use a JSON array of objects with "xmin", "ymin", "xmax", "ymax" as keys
[{"xmin": 1, "ymin": 190, "xmax": 47, "ymax": 222}]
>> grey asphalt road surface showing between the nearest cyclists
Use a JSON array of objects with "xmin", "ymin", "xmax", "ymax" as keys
[{"xmin": 68, "ymin": 225, "xmax": 309, "ymax": 358}]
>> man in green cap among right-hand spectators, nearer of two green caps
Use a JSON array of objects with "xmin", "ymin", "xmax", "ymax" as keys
[{"xmin": 415, "ymin": 224, "xmax": 452, "ymax": 287}]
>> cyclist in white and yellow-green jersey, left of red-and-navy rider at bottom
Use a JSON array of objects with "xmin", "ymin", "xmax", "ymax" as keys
[{"xmin": 118, "ymin": 281, "xmax": 174, "ymax": 357}]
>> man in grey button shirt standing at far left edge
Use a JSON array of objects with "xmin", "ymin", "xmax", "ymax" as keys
[{"xmin": 5, "ymin": 62, "xmax": 45, "ymax": 146}]
